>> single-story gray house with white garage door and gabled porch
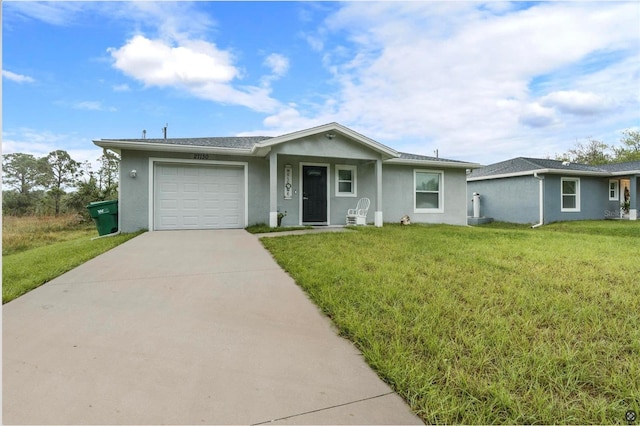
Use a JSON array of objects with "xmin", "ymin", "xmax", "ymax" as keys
[{"xmin": 93, "ymin": 123, "xmax": 480, "ymax": 232}]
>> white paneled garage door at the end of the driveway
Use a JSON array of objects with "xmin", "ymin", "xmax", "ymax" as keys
[{"xmin": 154, "ymin": 164, "xmax": 245, "ymax": 230}]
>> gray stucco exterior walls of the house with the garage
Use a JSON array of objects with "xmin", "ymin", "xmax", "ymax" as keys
[{"xmin": 119, "ymin": 135, "xmax": 467, "ymax": 232}]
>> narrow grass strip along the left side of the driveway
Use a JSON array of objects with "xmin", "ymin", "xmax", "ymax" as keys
[{"xmin": 2, "ymin": 230, "xmax": 142, "ymax": 304}]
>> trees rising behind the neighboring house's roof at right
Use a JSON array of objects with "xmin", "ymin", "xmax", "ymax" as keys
[{"xmin": 556, "ymin": 129, "xmax": 640, "ymax": 166}]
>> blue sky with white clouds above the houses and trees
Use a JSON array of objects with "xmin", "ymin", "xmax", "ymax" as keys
[{"xmin": 2, "ymin": 1, "xmax": 640, "ymax": 168}]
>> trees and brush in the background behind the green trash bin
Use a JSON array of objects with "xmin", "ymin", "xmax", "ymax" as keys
[{"xmin": 2, "ymin": 150, "xmax": 120, "ymax": 217}]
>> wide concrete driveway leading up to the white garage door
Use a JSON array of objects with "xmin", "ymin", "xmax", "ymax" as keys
[{"xmin": 2, "ymin": 230, "xmax": 421, "ymax": 424}]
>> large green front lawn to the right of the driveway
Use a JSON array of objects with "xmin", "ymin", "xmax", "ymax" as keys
[{"xmin": 261, "ymin": 221, "xmax": 640, "ymax": 424}]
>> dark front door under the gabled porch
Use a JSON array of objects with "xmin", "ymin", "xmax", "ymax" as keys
[{"xmin": 302, "ymin": 166, "xmax": 327, "ymax": 223}]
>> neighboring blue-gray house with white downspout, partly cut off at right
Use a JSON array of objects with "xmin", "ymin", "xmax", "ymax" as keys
[{"xmin": 467, "ymin": 157, "xmax": 640, "ymax": 224}]
